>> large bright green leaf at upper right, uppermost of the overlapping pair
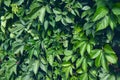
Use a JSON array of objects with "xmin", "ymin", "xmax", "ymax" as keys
[{"xmin": 93, "ymin": 6, "xmax": 108, "ymax": 21}]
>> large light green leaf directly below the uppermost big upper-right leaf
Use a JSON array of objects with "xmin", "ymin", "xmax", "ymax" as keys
[{"xmin": 96, "ymin": 16, "xmax": 109, "ymax": 31}]
